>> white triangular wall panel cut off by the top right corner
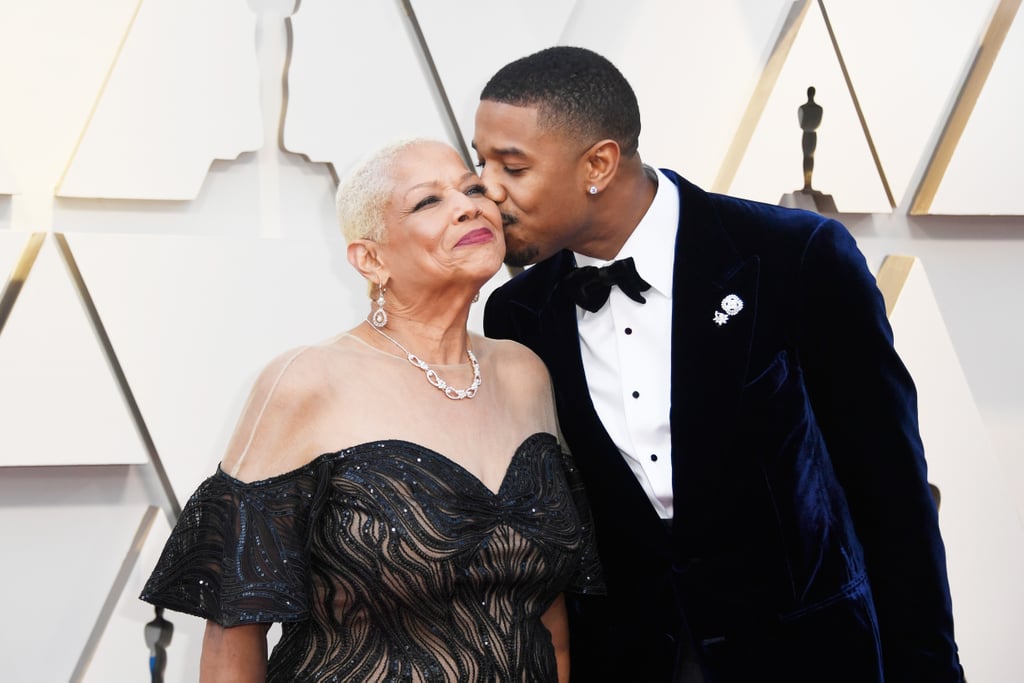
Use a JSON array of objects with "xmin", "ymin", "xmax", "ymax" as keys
[{"xmin": 929, "ymin": 10, "xmax": 1024, "ymax": 215}]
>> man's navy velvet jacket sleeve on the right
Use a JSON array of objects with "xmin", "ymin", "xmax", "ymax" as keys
[{"xmin": 799, "ymin": 220, "xmax": 963, "ymax": 683}]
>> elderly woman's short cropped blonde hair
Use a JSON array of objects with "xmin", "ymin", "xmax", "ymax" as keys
[{"xmin": 335, "ymin": 137, "xmax": 438, "ymax": 244}]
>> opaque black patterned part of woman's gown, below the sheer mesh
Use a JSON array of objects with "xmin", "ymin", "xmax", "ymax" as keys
[{"xmin": 142, "ymin": 433, "xmax": 603, "ymax": 682}]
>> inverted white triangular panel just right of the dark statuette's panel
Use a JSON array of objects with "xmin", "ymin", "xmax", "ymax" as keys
[{"xmin": 825, "ymin": 0, "xmax": 992, "ymax": 202}]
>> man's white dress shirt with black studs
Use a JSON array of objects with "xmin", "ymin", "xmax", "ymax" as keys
[{"xmin": 574, "ymin": 166, "xmax": 679, "ymax": 519}]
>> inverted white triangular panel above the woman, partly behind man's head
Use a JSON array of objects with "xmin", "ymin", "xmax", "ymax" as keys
[{"xmin": 413, "ymin": 0, "xmax": 579, "ymax": 156}]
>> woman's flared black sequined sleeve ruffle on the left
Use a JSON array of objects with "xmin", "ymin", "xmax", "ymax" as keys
[{"xmin": 139, "ymin": 465, "xmax": 322, "ymax": 627}]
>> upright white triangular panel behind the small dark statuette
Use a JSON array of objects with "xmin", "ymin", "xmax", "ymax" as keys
[{"xmin": 728, "ymin": 3, "xmax": 892, "ymax": 213}]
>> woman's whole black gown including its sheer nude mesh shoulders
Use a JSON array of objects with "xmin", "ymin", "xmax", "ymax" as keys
[{"xmin": 142, "ymin": 328, "xmax": 602, "ymax": 682}]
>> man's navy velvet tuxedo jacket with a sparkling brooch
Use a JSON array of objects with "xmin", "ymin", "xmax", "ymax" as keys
[{"xmin": 484, "ymin": 170, "xmax": 962, "ymax": 683}]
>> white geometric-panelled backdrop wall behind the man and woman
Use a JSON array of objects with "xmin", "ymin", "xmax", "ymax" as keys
[{"xmin": 0, "ymin": 0, "xmax": 1024, "ymax": 683}]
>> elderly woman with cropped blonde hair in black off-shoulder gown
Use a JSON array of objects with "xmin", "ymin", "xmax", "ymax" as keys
[{"xmin": 141, "ymin": 140, "xmax": 600, "ymax": 682}]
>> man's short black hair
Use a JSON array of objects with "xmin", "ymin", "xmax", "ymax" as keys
[{"xmin": 480, "ymin": 46, "xmax": 640, "ymax": 157}]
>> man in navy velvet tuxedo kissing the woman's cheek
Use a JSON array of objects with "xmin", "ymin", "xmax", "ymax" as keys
[{"xmin": 473, "ymin": 47, "xmax": 963, "ymax": 683}]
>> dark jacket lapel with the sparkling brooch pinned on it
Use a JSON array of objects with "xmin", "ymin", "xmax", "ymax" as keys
[{"xmin": 665, "ymin": 171, "xmax": 759, "ymax": 552}]
